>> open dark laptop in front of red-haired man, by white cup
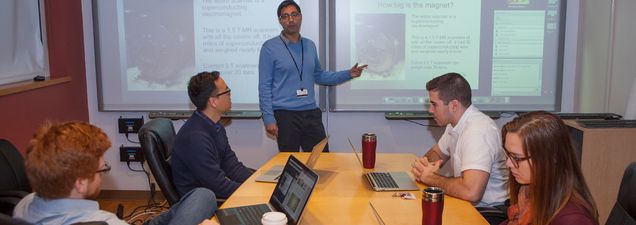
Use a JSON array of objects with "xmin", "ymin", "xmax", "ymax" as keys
[{"xmin": 216, "ymin": 156, "xmax": 318, "ymax": 225}]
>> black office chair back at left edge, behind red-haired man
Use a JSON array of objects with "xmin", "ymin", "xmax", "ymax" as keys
[{"xmin": 0, "ymin": 139, "xmax": 31, "ymax": 216}]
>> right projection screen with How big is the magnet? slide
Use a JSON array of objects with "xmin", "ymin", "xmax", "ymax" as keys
[{"xmin": 330, "ymin": 0, "xmax": 562, "ymax": 111}]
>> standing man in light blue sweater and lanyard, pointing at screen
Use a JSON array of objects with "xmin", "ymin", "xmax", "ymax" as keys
[{"xmin": 258, "ymin": 0, "xmax": 366, "ymax": 152}]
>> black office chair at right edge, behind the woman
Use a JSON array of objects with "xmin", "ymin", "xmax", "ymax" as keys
[{"xmin": 605, "ymin": 162, "xmax": 636, "ymax": 225}]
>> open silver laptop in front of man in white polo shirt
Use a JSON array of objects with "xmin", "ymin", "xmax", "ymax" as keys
[{"xmin": 349, "ymin": 139, "xmax": 419, "ymax": 191}]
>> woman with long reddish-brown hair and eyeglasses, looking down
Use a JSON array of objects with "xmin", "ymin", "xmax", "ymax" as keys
[{"xmin": 501, "ymin": 112, "xmax": 598, "ymax": 225}]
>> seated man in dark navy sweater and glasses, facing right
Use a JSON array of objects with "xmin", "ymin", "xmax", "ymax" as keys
[{"xmin": 171, "ymin": 71, "xmax": 253, "ymax": 198}]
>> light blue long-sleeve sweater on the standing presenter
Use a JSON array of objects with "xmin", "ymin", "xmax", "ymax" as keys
[{"xmin": 258, "ymin": 35, "xmax": 351, "ymax": 125}]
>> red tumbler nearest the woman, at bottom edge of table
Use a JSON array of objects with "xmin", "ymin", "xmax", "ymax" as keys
[{"xmin": 422, "ymin": 187, "xmax": 444, "ymax": 225}]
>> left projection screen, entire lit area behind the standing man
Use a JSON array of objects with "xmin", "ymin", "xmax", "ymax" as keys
[{"xmin": 96, "ymin": 0, "xmax": 318, "ymax": 111}]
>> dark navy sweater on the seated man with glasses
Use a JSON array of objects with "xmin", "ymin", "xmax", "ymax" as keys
[{"xmin": 171, "ymin": 111, "xmax": 252, "ymax": 198}]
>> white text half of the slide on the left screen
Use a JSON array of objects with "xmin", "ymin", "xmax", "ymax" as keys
[{"xmin": 194, "ymin": 0, "xmax": 281, "ymax": 103}]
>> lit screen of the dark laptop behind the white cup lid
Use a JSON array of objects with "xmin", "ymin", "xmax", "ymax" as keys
[{"xmin": 269, "ymin": 156, "xmax": 318, "ymax": 224}]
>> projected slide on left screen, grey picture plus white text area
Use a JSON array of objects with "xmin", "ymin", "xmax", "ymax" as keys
[{"xmin": 120, "ymin": 0, "xmax": 280, "ymax": 108}]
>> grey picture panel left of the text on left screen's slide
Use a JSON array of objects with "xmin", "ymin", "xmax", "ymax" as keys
[{"xmin": 123, "ymin": 0, "xmax": 195, "ymax": 91}]
